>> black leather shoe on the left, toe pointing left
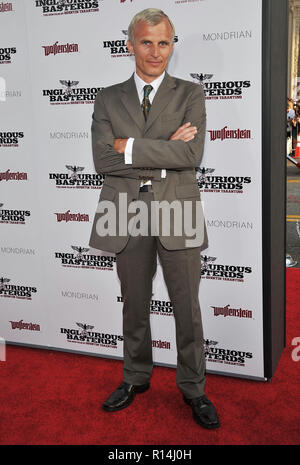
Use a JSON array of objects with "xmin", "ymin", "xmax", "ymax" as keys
[{"xmin": 102, "ymin": 382, "xmax": 150, "ymax": 412}]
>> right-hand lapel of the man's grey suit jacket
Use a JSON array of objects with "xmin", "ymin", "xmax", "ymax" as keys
[{"xmin": 144, "ymin": 73, "xmax": 176, "ymax": 133}]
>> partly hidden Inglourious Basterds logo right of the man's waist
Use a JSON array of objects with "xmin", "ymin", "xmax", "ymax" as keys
[{"xmin": 196, "ymin": 167, "xmax": 251, "ymax": 194}]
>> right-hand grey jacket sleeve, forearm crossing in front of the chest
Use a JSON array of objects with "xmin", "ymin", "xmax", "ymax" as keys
[{"xmin": 132, "ymin": 85, "xmax": 206, "ymax": 170}]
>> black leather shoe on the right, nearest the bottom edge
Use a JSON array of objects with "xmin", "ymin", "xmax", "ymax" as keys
[{"xmin": 183, "ymin": 395, "xmax": 220, "ymax": 429}]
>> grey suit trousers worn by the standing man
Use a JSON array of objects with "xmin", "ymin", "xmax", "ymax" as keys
[{"xmin": 116, "ymin": 192, "xmax": 205, "ymax": 399}]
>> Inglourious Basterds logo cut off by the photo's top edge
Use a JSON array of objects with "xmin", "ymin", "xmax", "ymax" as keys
[{"xmin": 35, "ymin": 0, "xmax": 103, "ymax": 16}]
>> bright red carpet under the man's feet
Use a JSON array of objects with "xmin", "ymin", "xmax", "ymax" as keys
[{"xmin": 0, "ymin": 269, "xmax": 300, "ymax": 445}]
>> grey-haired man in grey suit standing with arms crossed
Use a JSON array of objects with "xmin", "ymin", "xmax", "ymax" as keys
[{"xmin": 90, "ymin": 8, "xmax": 219, "ymax": 429}]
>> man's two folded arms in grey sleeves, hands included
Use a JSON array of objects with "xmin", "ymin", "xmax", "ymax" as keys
[{"xmin": 92, "ymin": 86, "xmax": 206, "ymax": 179}]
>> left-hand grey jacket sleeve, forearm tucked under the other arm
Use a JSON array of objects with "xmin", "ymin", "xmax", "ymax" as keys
[{"xmin": 92, "ymin": 92, "xmax": 161, "ymax": 180}]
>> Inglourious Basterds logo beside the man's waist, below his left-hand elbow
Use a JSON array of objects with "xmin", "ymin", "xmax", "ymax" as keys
[{"xmin": 49, "ymin": 165, "xmax": 104, "ymax": 189}]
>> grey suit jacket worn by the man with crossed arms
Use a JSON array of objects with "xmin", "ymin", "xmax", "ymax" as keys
[{"xmin": 90, "ymin": 73, "xmax": 206, "ymax": 253}]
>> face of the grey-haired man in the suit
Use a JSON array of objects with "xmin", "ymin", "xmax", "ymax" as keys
[{"xmin": 127, "ymin": 19, "xmax": 174, "ymax": 82}]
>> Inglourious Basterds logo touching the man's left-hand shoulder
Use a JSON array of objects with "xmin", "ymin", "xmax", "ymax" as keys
[{"xmin": 43, "ymin": 79, "xmax": 104, "ymax": 105}]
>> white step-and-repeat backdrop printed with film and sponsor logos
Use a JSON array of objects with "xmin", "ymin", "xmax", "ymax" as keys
[{"xmin": 0, "ymin": 0, "xmax": 263, "ymax": 379}]
